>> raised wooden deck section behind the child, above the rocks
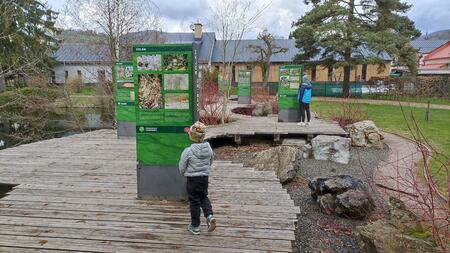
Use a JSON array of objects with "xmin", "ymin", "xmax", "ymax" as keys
[{"xmin": 207, "ymin": 114, "xmax": 348, "ymax": 142}]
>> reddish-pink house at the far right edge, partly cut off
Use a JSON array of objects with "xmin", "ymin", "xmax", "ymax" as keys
[{"xmin": 418, "ymin": 41, "xmax": 450, "ymax": 75}]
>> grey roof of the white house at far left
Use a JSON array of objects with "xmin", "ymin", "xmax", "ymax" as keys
[{"xmin": 54, "ymin": 43, "xmax": 110, "ymax": 63}]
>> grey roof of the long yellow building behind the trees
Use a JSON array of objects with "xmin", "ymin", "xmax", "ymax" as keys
[{"xmin": 212, "ymin": 39, "xmax": 392, "ymax": 63}]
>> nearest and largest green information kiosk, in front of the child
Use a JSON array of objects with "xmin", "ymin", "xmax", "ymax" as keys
[{"xmin": 133, "ymin": 43, "xmax": 198, "ymax": 199}]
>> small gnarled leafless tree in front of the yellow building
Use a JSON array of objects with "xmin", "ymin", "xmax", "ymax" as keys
[{"xmin": 248, "ymin": 29, "xmax": 288, "ymax": 87}]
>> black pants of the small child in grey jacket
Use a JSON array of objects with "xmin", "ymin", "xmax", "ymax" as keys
[{"xmin": 187, "ymin": 176, "xmax": 213, "ymax": 227}]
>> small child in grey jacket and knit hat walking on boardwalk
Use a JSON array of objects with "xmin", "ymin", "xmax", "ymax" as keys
[{"xmin": 179, "ymin": 121, "xmax": 216, "ymax": 235}]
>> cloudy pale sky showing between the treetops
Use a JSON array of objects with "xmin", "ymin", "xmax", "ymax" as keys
[{"xmin": 47, "ymin": 0, "xmax": 450, "ymax": 38}]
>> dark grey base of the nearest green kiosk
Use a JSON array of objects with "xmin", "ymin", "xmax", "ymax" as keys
[{"xmin": 137, "ymin": 164, "xmax": 187, "ymax": 200}]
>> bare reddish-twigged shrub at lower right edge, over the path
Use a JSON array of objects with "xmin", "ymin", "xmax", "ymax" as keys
[{"xmin": 377, "ymin": 109, "xmax": 450, "ymax": 252}]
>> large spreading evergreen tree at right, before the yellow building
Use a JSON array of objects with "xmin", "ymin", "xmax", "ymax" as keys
[{"xmin": 291, "ymin": 0, "xmax": 420, "ymax": 97}]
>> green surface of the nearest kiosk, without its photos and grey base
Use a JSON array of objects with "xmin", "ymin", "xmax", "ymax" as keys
[{"xmin": 133, "ymin": 44, "xmax": 194, "ymax": 166}]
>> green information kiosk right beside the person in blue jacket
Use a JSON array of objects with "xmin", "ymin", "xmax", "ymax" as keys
[{"xmin": 278, "ymin": 65, "xmax": 303, "ymax": 122}]
